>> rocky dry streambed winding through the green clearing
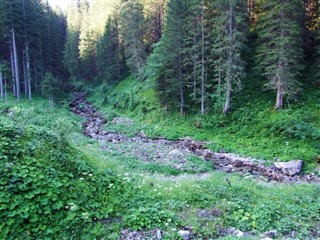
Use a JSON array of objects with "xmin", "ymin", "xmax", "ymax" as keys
[{"xmin": 69, "ymin": 93, "xmax": 320, "ymax": 183}]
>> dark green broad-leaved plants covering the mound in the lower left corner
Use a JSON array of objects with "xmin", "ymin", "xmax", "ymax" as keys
[{"xmin": 0, "ymin": 125, "xmax": 124, "ymax": 239}]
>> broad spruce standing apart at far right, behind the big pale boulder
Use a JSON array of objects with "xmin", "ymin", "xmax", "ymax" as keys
[{"xmin": 256, "ymin": 0, "xmax": 303, "ymax": 109}]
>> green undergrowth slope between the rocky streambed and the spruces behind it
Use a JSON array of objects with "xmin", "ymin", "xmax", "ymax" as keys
[{"xmin": 90, "ymin": 77, "xmax": 320, "ymax": 171}]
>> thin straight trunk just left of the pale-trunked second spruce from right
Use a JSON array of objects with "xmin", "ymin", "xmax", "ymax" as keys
[{"xmin": 201, "ymin": 0, "xmax": 205, "ymax": 115}]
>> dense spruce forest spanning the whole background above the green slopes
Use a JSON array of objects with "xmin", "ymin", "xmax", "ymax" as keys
[{"xmin": 0, "ymin": 0, "xmax": 320, "ymax": 114}]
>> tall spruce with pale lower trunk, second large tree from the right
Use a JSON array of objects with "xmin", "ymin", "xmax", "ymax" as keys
[{"xmin": 212, "ymin": 0, "xmax": 248, "ymax": 113}]
